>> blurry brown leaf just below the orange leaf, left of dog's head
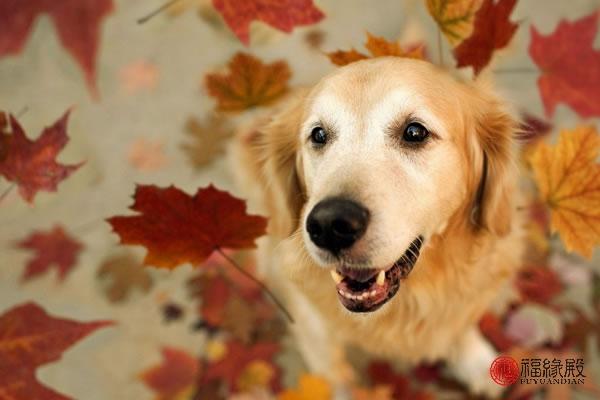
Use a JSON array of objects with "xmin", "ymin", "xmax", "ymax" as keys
[{"xmin": 181, "ymin": 115, "xmax": 234, "ymax": 169}]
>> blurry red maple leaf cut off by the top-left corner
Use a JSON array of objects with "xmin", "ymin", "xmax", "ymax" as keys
[{"xmin": 0, "ymin": 0, "xmax": 113, "ymax": 96}]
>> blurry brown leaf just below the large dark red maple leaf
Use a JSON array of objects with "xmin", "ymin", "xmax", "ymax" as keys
[{"xmin": 97, "ymin": 254, "xmax": 153, "ymax": 303}]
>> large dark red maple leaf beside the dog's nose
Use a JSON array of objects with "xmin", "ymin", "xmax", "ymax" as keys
[{"xmin": 107, "ymin": 185, "xmax": 267, "ymax": 269}]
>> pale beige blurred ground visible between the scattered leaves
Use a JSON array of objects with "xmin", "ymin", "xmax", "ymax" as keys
[{"xmin": 0, "ymin": 0, "xmax": 600, "ymax": 399}]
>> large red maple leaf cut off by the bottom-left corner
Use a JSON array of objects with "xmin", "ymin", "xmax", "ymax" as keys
[{"xmin": 0, "ymin": 303, "xmax": 112, "ymax": 400}]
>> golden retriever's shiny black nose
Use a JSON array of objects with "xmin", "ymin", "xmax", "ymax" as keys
[{"xmin": 306, "ymin": 197, "xmax": 369, "ymax": 254}]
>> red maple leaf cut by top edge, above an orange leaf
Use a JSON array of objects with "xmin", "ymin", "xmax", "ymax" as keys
[{"xmin": 213, "ymin": 0, "xmax": 325, "ymax": 46}]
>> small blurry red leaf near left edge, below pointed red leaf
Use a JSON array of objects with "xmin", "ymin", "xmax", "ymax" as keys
[{"xmin": 17, "ymin": 225, "xmax": 83, "ymax": 281}]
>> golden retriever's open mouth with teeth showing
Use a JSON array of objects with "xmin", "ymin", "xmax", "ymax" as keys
[{"xmin": 331, "ymin": 236, "xmax": 423, "ymax": 312}]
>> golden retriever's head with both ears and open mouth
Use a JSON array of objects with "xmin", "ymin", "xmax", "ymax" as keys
[{"xmin": 263, "ymin": 58, "xmax": 515, "ymax": 312}]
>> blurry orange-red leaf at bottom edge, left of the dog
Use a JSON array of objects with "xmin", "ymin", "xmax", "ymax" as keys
[{"xmin": 140, "ymin": 347, "xmax": 199, "ymax": 400}]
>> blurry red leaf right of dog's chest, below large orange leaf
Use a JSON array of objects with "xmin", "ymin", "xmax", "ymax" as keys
[{"xmin": 515, "ymin": 266, "xmax": 563, "ymax": 304}]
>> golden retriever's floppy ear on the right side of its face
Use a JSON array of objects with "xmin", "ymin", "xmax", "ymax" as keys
[{"xmin": 471, "ymin": 88, "xmax": 518, "ymax": 236}]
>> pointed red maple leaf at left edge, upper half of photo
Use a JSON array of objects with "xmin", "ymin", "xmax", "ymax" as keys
[{"xmin": 0, "ymin": 111, "xmax": 83, "ymax": 203}]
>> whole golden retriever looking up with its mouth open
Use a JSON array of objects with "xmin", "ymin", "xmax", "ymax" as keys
[{"xmin": 231, "ymin": 57, "xmax": 524, "ymax": 394}]
